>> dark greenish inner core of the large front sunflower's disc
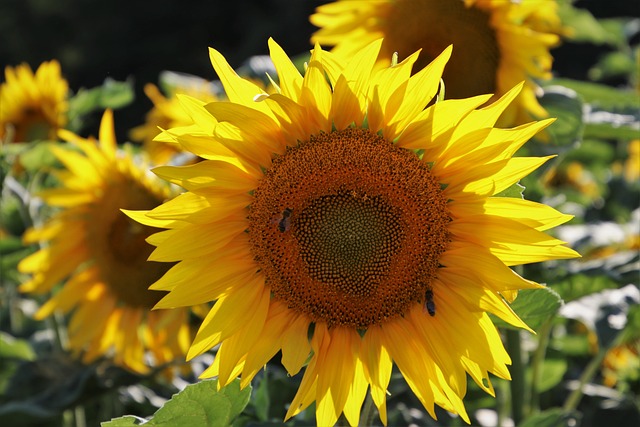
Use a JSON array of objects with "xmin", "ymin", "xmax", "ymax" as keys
[{"xmin": 294, "ymin": 194, "xmax": 404, "ymax": 296}]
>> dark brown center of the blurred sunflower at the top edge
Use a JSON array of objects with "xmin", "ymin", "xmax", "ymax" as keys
[{"xmin": 382, "ymin": 0, "xmax": 500, "ymax": 98}]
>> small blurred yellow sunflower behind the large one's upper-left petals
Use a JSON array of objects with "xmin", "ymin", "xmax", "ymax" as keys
[{"xmin": 130, "ymin": 80, "xmax": 217, "ymax": 164}]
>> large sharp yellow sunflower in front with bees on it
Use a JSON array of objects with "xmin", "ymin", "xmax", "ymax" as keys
[{"xmin": 129, "ymin": 40, "xmax": 577, "ymax": 426}]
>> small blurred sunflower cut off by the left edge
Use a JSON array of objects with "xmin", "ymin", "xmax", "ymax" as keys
[{"xmin": 0, "ymin": 60, "xmax": 69, "ymax": 142}]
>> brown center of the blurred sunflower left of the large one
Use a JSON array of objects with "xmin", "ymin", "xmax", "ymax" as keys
[{"xmin": 89, "ymin": 178, "xmax": 172, "ymax": 309}]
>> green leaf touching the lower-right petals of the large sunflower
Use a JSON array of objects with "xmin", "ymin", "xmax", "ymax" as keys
[{"xmin": 491, "ymin": 288, "xmax": 562, "ymax": 330}]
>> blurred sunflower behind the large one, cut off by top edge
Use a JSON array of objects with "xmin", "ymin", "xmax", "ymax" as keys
[{"xmin": 310, "ymin": 0, "xmax": 563, "ymax": 125}]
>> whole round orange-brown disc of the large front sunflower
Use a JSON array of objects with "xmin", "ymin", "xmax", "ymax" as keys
[{"xmin": 249, "ymin": 129, "xmax": 450, "ymax": 328}]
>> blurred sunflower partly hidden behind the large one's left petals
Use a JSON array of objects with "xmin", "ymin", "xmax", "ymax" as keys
[{"xmin": 18, "ymin": 111, "xmax": 192, "ymax": 373}]
